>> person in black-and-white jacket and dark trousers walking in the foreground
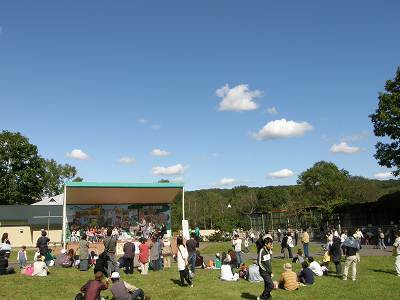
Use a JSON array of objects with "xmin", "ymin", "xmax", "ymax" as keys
[{"xmin": 257, "ymin": 237, "xmax": 274, "ymax": 300}]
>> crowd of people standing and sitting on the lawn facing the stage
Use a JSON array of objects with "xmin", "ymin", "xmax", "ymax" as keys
[{"xmin": 0, "ymin": 228, "xmax": 400, "ymax": 300}]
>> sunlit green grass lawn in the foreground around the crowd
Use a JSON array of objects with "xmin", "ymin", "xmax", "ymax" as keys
[{"xmin": 0, "ymin": 243, "xmax": 400, "ymax": 300}]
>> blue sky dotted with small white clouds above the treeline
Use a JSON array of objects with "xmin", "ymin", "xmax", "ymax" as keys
[{"xmin": 0, "ymin": 1, "xmax": 400, "ymax": 189}]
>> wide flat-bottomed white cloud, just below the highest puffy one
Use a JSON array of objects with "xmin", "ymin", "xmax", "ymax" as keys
[{"xmin": 252, "ymin": 119, "xmax": 313, "ymax": 140}]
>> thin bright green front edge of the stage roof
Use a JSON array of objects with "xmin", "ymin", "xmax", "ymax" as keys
[{"xmin": 65, "ymin": 181, "xmax": 183, "ymax": 188}]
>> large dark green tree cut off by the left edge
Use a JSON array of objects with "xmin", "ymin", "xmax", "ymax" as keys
[{"xmin": 0, "ymin": 131, "xmax": 45, "ymax": 204}]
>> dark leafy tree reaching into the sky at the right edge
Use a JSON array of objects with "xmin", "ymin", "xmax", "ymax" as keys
[{"xmin": 370, "ymin": 67, "xmax": 400, "ymax": 176}]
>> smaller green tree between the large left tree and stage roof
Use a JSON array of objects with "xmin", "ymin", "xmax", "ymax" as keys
[{"xmin": 43, "ymin": 159, "xmax": 82, "ymax": 197}]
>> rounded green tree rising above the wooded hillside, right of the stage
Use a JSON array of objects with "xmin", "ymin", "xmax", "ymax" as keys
[{"xmin": 297, "ymin": 161, "xmax": 349, "ymax": 211}]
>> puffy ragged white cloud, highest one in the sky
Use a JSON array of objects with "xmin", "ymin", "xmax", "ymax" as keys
[{"xmin": 215, "ymin": 84, "xmax": 262, "ymax": 111}]
